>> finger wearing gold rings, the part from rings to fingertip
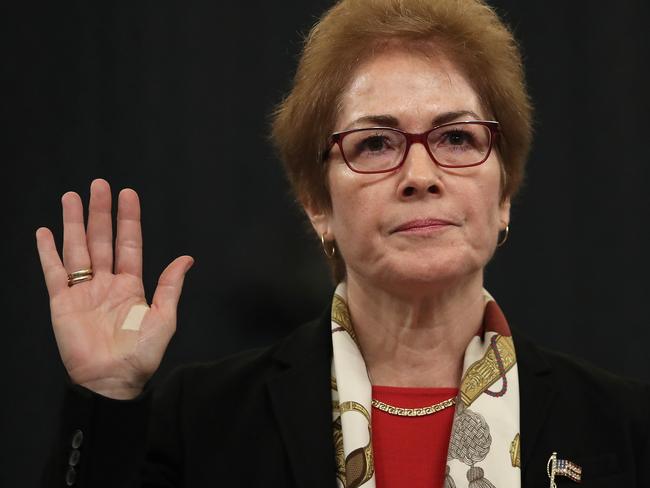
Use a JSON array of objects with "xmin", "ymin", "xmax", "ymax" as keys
[{"xmin": 61, "ymin": 191, "xmax": 91, "ymax": 274}]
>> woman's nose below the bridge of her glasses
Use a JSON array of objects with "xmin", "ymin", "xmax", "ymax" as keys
[{"xmin": 398, "ymin": 139, "xmax": 442, "ymax": 199}]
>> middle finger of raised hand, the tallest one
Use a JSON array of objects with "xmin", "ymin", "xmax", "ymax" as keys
[{"xmin": 86, "ymin": 179, "xmax": 113, "ymax": 273}]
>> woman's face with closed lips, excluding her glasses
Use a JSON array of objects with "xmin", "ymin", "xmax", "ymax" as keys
[{"xmin": 308, "ymin": 50, "xmax": 510, "ymax": 292}]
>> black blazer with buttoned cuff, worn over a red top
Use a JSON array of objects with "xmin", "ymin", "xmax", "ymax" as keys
[{"xmin": 44, "ymin": 316, "xmax": 650, "ymax": 488}]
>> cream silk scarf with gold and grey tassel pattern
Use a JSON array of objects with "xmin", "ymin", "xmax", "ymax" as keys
[{"xmin": 332, "ymin": 283, "xmax": 521, "ymax": 488}]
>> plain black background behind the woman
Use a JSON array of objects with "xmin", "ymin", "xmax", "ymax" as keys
[{"xmin": 0, "ymin": 0, "xmax": 650, "ymax": 487}]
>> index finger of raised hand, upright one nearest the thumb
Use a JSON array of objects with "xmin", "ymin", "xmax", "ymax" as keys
[{"xmin": 115, "ymin": 188, "xmax": 142, "ymax": 277}]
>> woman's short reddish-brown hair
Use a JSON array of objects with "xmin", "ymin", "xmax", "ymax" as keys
[{"xmin": 272, "ymin": 0, "xmax": 532, "ymax": 280}]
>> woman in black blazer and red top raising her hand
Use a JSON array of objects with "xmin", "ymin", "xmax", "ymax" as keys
[{"xmin": 37, "ymin": 0, "xmax": 650, "ymax": 488}]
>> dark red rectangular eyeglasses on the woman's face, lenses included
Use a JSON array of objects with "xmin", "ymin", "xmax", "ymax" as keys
[{"xmin": 330, "ymin": 120, "xmax": 499, "ymax": 174}]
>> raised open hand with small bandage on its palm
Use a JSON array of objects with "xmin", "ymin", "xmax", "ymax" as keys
[{"xmin": 36, "ymin": 179, "xmax": 194, "ymax": 399}]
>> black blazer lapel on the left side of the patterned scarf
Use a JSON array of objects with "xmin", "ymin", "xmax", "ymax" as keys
[{"xmin": 267, "ymin": 314, "xmax": 336, "ymax": 488}]
